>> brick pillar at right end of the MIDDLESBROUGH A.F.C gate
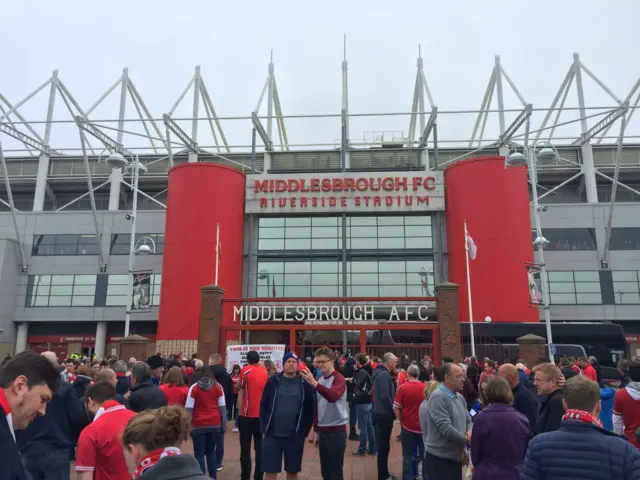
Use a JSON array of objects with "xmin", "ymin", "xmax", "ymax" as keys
[{"xmin": 434, "ymin": 282, "xmax": 462, "ymax": 362}]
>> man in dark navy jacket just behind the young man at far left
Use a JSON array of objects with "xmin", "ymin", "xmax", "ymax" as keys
[{"xmin": 16, "ymin": 352, "xmax": 88, "ymax": 479}]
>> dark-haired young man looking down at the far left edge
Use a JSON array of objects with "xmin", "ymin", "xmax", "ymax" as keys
[{"xmin": 0, "ymin": 351, "xmax": 60, "ymax": 480}]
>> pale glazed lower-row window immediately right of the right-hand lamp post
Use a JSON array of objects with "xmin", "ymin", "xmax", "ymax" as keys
[{"xmin": 547, "ymin": 271, "xmax": 602, "ymax": 305}]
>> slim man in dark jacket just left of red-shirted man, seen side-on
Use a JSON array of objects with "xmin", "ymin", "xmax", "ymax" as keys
[{"xmin": 373, "ymin": 353, "xmax": 398, "ymax": 480}]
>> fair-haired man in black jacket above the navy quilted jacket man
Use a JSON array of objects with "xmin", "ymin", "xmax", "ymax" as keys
[{"xmin": 533, "ymin": 363, "xmax": 564, "ymax": 435}]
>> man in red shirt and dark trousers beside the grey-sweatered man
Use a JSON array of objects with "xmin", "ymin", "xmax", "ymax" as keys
[{"xmin": 393, "ymin": 365, "xmax": 424, "ymax": 478}]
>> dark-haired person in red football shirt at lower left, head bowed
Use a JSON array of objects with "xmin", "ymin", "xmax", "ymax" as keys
[{"xmin": 76, "ymin": 381, "xmax": 135, "ymax": 480}]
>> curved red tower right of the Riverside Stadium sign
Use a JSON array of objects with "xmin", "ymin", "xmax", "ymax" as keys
[{"xmin": 445, "ymin": 157, "xmax": 538, "ymax": 322}]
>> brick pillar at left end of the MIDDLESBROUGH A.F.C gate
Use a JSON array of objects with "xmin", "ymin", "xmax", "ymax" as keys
[{"xmin": 198, "ymin": 285, "xmax": 224, "ymax": 363}]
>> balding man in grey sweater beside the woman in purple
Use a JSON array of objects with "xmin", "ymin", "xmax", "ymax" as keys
[{"xmin": 425, "ymin": 363, "xmax": 471, "ymax": 480}]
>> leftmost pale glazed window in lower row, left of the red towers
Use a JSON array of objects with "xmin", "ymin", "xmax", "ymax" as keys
[{"xmin": 26, "ymin": 275, "xmax": 97, "ymax": 307}]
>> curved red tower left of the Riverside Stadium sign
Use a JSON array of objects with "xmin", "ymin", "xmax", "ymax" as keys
[{"xmin": 157, "ymin": 163, "xmax": 245, "ymax": 340}]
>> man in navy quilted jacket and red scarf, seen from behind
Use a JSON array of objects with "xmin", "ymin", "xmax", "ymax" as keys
[{"xmin": 521, "ymin": 375, "xmax": 640, "ymax": 480}]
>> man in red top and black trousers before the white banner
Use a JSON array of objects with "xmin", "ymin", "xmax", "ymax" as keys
[{"xmin": 238, "ymin": 350, "xmax": 269, "ymax": 480}]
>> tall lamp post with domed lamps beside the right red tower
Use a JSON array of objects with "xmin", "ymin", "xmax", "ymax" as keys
[{"xmin": 505, "ymin": 142, "xmax": 558, "ymax": 363}]
